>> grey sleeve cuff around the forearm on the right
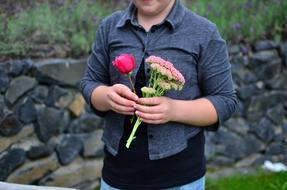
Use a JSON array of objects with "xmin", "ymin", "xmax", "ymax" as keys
[{"xmin": 205, "ymin": 96, "xmax": 224, "ymax": 131}]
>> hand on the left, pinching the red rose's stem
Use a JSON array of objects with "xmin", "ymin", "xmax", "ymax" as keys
[{"xmin": 107, "ymin": 84, "xmax": 138, "ymax": 115}]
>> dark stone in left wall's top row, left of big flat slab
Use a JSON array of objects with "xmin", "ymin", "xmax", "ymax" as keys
[{"xmin": 8, "ymin": 60, "xmax": 33, "ymax": 77}]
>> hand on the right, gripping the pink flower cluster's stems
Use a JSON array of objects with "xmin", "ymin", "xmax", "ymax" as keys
[{"xmin": 135, "ymin": 96, "xmax": 174, "ymax": 124}]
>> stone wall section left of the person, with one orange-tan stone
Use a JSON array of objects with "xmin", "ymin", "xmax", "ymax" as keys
[{"xmin": 0, "ymin": 59, "xmax": 103, "ymax": 189}]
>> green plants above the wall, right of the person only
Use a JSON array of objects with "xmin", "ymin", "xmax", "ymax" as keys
[{"xmin": 187, "ymin": 0, "xmax": 287, "ymax": 42}]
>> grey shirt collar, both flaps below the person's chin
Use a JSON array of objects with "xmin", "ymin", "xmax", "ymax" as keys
[{"xmin": 116, "ymin": 0, "xmax": 187, "ymax": 30}]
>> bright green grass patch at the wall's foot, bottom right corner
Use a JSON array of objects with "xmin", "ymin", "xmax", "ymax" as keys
[{"xmin": 206, "ymin": 171, "xmax": 287, "ymax": 190}]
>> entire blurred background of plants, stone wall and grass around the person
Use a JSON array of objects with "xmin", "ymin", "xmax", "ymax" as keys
[{"xmin": 0, "ymin": 0, "xmax": 287, "ymax": 190}]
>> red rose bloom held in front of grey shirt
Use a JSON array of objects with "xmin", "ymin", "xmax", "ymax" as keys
[{"xmin": 113, "ymin": 54, "xmax": 136, "ymax": 75}]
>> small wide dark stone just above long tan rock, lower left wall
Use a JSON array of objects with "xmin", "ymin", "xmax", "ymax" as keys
[{"xmin": 27, "ymin": 143, "xmax": 55, "ymax": 160}]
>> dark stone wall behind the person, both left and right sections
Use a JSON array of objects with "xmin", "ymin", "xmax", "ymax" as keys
[{"xmin": 0, "ymin": 41, "xmax": 287, "ymax": 189}]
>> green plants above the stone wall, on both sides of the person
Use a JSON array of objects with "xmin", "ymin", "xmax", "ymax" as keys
[{"xmin": 0, "ymin": 0, "xmax": 287, "ymax": 57}]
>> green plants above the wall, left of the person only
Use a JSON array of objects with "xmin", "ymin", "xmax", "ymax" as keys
[{"xmin": 0, "ymin": 0, "xmax": 111, "ymax": 56}]
